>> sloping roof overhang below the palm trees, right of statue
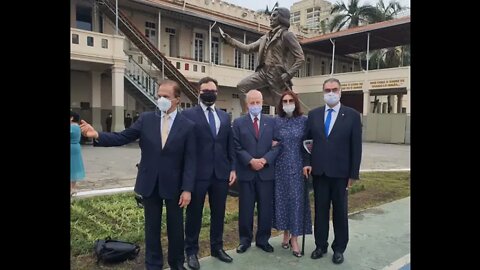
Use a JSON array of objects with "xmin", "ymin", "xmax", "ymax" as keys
[{"xmin": 300, "ymin": 16, "xmax": 410, "ymax": 55}]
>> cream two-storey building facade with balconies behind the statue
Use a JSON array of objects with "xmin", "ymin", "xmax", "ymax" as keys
[{"xmin": 70, "ymin": 0, "xmax": 409, "ymax": 143}]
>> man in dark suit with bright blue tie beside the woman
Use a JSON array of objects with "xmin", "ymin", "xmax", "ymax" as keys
[{"xmin": 303, "ymin": 78, "xmax": 362, "ymax": 264}]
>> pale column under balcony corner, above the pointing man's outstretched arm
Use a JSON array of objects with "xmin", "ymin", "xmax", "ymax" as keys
[{"xmin": 112, "ymin": 64, "xmax": 125, "ymax": 132}]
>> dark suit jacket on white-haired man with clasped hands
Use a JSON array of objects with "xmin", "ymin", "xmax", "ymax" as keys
[{"xmin": 233, "ymin": 114, "xmax": 281, "ymax": 181}]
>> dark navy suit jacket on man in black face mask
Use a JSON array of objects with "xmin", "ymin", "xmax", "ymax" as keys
[{"xmin": 182, "ymin": 106, "xmax": 235, "ymax": 181}]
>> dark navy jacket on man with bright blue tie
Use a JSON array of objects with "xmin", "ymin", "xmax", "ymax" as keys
[{"xmin": 304, "ymin": 104, "xmax": 362, "ymax": 179}]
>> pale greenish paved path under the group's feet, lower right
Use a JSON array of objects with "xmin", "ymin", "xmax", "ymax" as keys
[{"xmin": 178, "ymin": 197, "xmax": 410, "ymax": 270}]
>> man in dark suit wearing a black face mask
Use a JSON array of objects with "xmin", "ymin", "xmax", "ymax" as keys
[{"xmin": 182, "ymin": 77, "xmax": 236, "ymax": 269}]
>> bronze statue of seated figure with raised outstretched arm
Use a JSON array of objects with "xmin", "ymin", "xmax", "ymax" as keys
[{"xmin": 219, "ymin": 8, "xmax": 305, "ymax": 106}]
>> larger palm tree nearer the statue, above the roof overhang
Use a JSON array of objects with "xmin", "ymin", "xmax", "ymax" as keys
[{"xmin": 330, "ymin": 0, "xmax": 378, "ymax": 32}]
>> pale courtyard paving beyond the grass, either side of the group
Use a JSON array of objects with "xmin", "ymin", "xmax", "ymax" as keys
[{"xmin": 78, "ymin": 142, "xmax": 410, "ymax": 193}]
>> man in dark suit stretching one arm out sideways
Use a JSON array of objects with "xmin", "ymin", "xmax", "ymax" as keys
[{"xmin": 80, "ymin": 80, "xmax": 196, "ymax": 270}]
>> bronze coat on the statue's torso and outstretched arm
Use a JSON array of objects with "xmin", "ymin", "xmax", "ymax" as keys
[{"xmin": 227, "ymin": 27, "xmax": 305, "ymax": 77}]
